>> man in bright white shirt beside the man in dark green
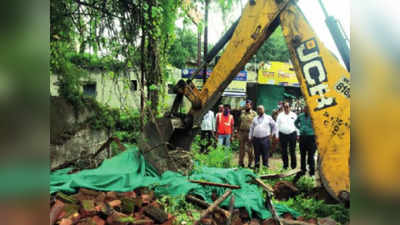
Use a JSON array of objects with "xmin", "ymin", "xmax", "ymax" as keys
[{"xmin": 276, "ymin": 102, "xmax": 297, "ymax": 169}]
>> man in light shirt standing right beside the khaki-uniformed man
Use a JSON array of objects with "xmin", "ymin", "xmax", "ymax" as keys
[{"xmin": 249, "ymin": 105, "xmax": 276, "ymax": 170}]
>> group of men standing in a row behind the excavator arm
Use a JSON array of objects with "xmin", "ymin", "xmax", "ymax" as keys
[{"xmin": 201, "ymin": 100, "xmax": 316, "ymax": 176}]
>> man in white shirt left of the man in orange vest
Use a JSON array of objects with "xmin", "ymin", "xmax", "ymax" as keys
[{"xmin": 200, "ymin": 110, "xmax": 215, "ymax": 152}]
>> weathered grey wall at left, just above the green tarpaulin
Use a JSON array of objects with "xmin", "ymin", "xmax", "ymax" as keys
[{"xmin": 49, "ymin": 97, "xmax": 110, "ymax": 169}]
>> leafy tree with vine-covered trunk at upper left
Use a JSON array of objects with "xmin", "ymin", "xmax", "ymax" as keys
[{"xmin": 50, "ymin": 0, "xmax": 181, "ymax": 128}]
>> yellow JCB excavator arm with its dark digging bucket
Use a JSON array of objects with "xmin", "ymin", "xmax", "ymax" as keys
[{"xmin": 139, "ymin": 0, "xmax": 350, "ymax": 204}]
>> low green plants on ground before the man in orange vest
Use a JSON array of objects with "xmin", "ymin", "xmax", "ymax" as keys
[{"xmin": 192, "ymin": 135, "xmax": 234, "ymax": 168}]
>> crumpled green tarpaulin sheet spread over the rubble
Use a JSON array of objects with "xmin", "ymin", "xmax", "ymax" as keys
[{"xmin": 50, "ymin": 147, "xmax": 299, "ymax": 219}]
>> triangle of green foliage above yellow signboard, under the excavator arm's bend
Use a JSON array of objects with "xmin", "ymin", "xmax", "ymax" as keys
[{"xmin": 254, "ymin": 26, "xmax": 290, "ymax": 62}]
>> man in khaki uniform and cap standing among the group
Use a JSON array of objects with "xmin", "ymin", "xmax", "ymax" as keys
[{"xmin": 239, "ymin": 100, "xmax": 257, "ymax": 167}]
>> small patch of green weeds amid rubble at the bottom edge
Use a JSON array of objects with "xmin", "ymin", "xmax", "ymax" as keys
[{"xmin": 158, "ymin": 196, "xmax": 200, "ymax": 225}]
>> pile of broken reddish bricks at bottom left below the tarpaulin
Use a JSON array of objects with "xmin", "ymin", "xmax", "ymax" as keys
[{"xmin": 50, "ymin": 188, "xmax": 175, "ymax": 225}]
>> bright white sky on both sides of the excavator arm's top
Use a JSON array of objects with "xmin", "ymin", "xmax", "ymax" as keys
[{"xmin": 189, "ymin": 0, "xmax": 350, "ymax": 64}]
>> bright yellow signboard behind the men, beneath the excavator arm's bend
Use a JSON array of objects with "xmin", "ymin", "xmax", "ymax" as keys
[{"xmin": 258, "ymin": 61, "xmax": 299, "ymax": 87}]
